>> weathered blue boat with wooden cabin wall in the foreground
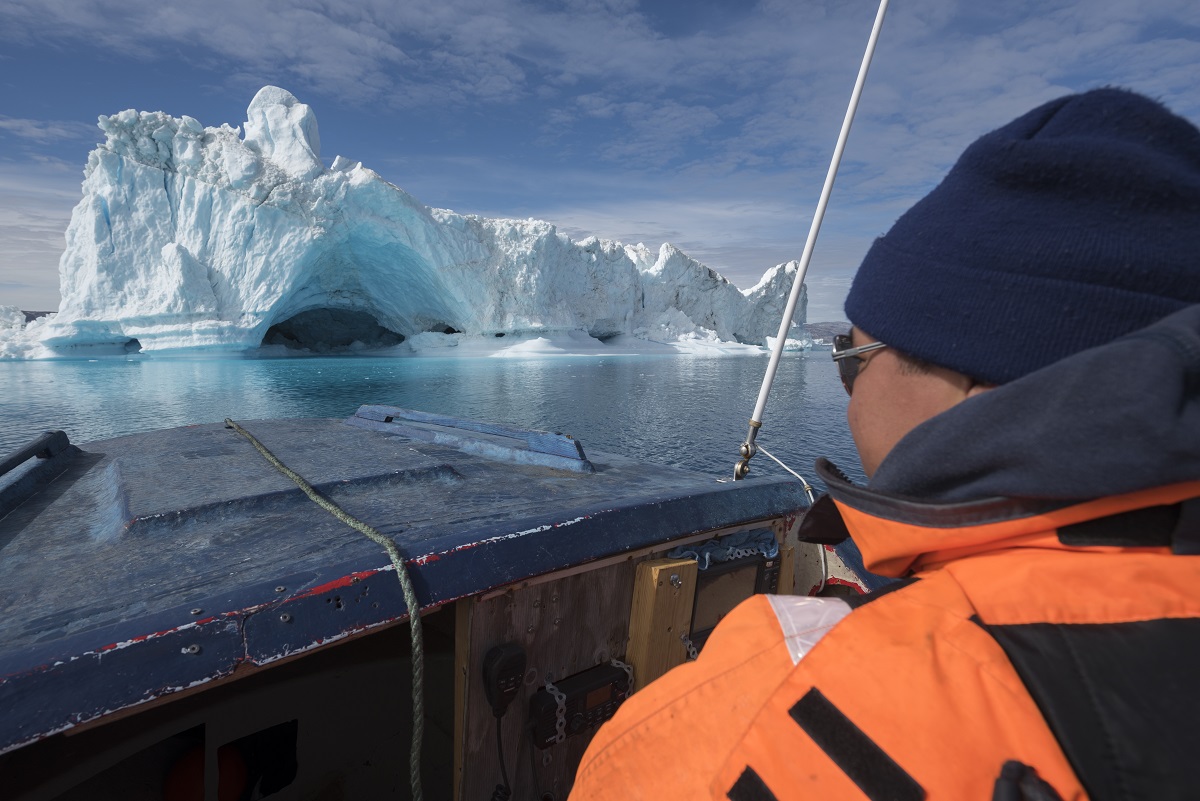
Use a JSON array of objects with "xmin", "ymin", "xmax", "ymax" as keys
[{"xmin": 0, "ymin": 405, "xmax": 864, "ymax": 801}]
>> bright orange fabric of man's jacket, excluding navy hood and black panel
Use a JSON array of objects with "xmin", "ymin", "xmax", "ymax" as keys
[{"xmin": 571, "ymin": 482, "xmax": 1200, "ymax": 801}]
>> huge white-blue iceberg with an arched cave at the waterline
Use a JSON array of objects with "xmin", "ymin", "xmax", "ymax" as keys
[{"xmin": 7, "ymin": 86, "xmax": 805, "ymax": 357}]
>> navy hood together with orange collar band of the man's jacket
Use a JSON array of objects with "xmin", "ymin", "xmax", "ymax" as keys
[{"xmin": 817, "ymin": 306, "xmax": 1200, "ymax": 576}]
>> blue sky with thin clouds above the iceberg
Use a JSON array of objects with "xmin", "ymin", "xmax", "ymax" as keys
[{"xmin": 0, "ymin": 0, "xmax": 1200, "ymax": 321}]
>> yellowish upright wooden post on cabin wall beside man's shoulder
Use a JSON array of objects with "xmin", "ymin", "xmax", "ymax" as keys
[{"xmin": 629, "ymin": 559, "xmax": 697, "ymax": 688}]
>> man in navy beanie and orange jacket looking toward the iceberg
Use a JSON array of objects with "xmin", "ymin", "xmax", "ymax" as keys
[{"xmin": 571, "ymin": 89, "xmax": 1200, "ymax": 801}]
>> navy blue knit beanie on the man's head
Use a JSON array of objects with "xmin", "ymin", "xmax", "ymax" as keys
[{"xmin": 846, "ymin": 89, "xmax": 1200, "ymax": 384}]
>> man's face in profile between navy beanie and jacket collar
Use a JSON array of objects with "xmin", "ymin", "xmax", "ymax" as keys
[{"xmin": 846, "ymin": 327, "xmax": 990, "ymax": 477}]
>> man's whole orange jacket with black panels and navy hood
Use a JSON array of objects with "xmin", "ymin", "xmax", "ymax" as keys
[{"xmin": 571, "ymin": 306, "xmax": 1200, "ymax": 801}]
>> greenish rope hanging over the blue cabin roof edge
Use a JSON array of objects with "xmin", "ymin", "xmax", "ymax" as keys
[{"xmin": 226, "ymin": 417, "xmax": 425, "ymax": 801}]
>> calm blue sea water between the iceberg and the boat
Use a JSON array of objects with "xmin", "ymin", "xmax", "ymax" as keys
[{"xmin": 0, "ymin": 350, "xmax": 862, "ymax": 489}]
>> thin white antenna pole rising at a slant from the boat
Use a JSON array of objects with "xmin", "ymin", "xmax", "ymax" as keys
[{"xmin": 733, "ymin": 0, "xmax": 888, "ymax": 478}]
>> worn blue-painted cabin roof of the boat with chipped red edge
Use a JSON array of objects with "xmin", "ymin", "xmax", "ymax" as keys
[{"xmin": 0, "ymin": 407, "xmax": 804, "ymax": 752}]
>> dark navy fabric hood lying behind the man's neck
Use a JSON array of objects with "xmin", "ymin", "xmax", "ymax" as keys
[{"xmin": 870, "ymin": 305, "xmax": 1200, "ymax": 502}]
